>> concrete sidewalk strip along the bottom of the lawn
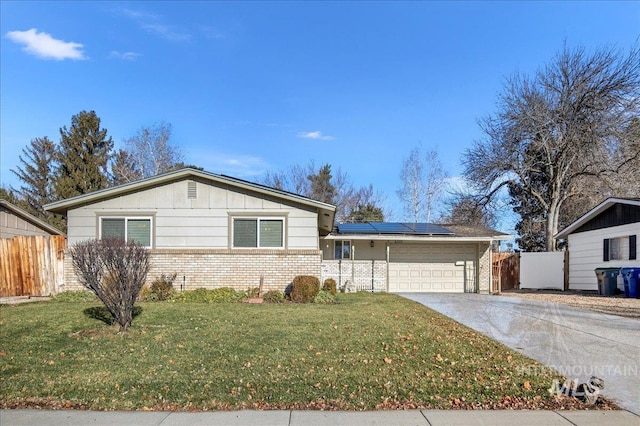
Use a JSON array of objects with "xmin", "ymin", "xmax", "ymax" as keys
[{"xmin": 0, "ymin": 410, "xmax": 640, "ymax": 426}]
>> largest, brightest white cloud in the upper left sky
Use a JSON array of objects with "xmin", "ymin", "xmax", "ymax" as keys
[{"xmin": 6, "ymin": 28, "xmax": 87, "ymax": 61}]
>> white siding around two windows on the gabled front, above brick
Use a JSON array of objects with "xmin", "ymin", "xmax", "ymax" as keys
[{"xmin": 68, "ymin": 179, "xmax": 319, "ymax": 250}]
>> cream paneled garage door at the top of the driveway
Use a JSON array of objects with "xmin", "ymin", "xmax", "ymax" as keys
[{"xmin": 389, "ymin": 244, "xmax": 476, "ymax": 293}]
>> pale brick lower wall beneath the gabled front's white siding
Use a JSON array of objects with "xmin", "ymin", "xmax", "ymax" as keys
[{"xmin": 60, "ymin": 249, "xmax": 321, "ymax": 291}]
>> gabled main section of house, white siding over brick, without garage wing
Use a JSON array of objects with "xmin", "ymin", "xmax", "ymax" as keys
[{"xmin": 45, "ymin": 168, "xmax": 335, "ymax": 290}]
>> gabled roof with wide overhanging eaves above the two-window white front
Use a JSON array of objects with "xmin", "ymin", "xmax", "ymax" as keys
[{"xmin": 44, "ymin": 168, "xmax": 336, "ymax": 233}]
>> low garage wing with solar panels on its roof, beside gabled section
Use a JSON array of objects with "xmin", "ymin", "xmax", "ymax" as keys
[{"xmin": 321, "ymin": 222, "xmax": 510, "ymax": 293}]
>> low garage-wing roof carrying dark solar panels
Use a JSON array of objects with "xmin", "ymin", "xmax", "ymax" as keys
[{"xmin": 326, "ymin": 222, "xmax": 511, "ymax": 242}]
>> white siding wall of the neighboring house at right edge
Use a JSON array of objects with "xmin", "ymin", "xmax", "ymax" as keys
[{"xmin": 568, "ymin": 223, "xmax": 640, "ymax": 290}]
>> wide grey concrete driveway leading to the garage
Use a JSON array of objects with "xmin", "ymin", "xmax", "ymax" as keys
[{"xmin": 400, "ymin": 293, "xmax": 640, "ymax": 415}]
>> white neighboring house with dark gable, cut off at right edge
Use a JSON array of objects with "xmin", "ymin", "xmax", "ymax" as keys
[{"xmin": 555, "ymin": 198, "xmax": 640, "ymax": 290}]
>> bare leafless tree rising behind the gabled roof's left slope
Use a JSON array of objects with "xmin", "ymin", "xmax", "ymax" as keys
[{"xmin": 112, "ymin": 122, "xmax": 183, "ymax": 183}]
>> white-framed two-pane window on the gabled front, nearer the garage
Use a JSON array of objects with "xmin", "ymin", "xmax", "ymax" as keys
[{"xmin": 233, "ymin": 217, "xmax": 284, "ymax": 248}]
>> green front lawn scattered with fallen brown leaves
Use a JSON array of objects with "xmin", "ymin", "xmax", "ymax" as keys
[{"xmin": 0, "ymin": 293, "xmax": 558, "ymax": 410}]
